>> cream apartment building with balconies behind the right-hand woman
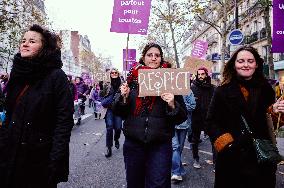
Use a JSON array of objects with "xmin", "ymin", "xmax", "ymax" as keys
[{"xmin": 183, "ymin": 0, "xmax": 284, "ymax": 80}]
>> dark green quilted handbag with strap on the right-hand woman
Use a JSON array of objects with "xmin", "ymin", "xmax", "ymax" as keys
[{"xmin": 241, "ymin": 116, "xmax": 284, "ymax": 164}]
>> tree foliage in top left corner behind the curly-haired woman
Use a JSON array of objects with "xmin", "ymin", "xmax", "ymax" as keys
[{"xmin": 0, "ymin": 0, "xmax": 47, "ymax": 71}]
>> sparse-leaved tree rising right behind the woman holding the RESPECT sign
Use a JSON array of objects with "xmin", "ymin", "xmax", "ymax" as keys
[{"xmin": 148, "ymin": 0, "xmax": 199, "ymax": 67}]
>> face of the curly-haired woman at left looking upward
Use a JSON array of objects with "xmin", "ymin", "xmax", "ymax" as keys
[{"xmin": 20, "ymin": 31, "xmax": 43, "ymax": 58}]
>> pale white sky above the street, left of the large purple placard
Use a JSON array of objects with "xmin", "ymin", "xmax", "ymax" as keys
[{"xmin": 45, "ymin": 0, "xmax": 143, "ymax": 70}]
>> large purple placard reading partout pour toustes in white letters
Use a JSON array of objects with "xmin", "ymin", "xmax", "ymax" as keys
[{"xmin": 110, "ymin": 0, "xmax": 151, "ymax": 35}]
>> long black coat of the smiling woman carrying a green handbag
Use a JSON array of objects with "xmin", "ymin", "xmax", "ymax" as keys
[{"xmin": 207, "ymin": 81, "xmax": 276, "ymax": 188}]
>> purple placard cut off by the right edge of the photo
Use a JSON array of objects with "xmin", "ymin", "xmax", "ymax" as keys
[{"xmin": 272, "ymin": 0, "xmax": 284, "ymax": 53}]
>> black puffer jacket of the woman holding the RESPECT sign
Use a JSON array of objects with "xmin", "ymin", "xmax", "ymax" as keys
[{"xmin": 113, "ymin": 89, "xmax": 187, "ymax": 143}]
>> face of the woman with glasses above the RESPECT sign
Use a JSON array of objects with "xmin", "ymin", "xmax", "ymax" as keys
[{"xmin": 143, "ymin": 47, "xmax": 162, "ymax": 69}]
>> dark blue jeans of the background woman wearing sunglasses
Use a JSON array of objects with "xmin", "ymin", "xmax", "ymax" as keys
[{"xmin": 105, "ymin": 109, "xmax": 122, "ymax": 147}]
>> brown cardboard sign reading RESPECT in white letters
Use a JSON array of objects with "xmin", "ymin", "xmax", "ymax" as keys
[{"xmin": 138, "ymin": 68, "xmax": 190, "ymax": 97}]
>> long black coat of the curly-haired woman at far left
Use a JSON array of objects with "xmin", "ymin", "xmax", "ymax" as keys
[{"xmin": 0, "ymin": 69, "xmax": 74, "ymax": 187}]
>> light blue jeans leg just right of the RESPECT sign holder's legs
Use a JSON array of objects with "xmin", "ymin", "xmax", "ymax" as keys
[{"xmin": 172, "ymin": 129, "xmax": 188, "ymax": 176}]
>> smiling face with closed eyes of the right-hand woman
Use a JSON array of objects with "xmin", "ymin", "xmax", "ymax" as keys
[{"xmin": 235, "ymin": 50, "xmax": 258, "ymax": 80}]
